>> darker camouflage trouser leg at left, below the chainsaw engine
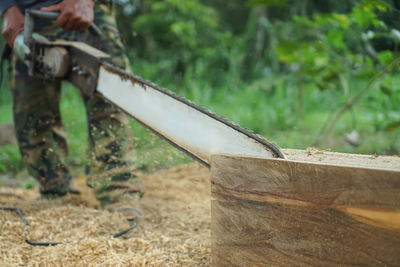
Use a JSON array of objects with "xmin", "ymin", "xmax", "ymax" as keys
[{"xmin": 11, "ymin": 57, "xmax": 70, "ymax": 196}]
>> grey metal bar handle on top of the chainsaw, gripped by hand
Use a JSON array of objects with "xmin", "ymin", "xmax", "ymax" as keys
[{"xmin": 24, "ymin": 9, "xmax": 102, "ymax": 45}]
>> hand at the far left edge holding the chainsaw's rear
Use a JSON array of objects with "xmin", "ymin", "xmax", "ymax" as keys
[{"xmin": 1, "ymin": 6, "xmax": 25, "ymax": 48}]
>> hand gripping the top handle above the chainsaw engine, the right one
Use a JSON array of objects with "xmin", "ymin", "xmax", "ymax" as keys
[{"xmin": 41, "ymin": 0, "xmax": 94, "ymax": 31}]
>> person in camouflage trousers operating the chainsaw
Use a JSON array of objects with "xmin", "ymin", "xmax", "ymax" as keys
[{"xmin": 0, "ymin": 0, "xmax": 144, "ymax": 217}]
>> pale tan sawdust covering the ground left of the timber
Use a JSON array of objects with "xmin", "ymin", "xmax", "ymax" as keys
[{"xmin": 0, "ymin": 163, "xmax": 211, "ymax": 266}]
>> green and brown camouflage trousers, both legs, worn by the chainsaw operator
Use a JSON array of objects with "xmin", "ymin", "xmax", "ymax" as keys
[{"xmin": 11, "ymin": 1, "xmax": 144, "ymax": 201}]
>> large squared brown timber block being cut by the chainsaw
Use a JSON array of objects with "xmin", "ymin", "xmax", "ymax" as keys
[{"xmin": 211, "ymin": 150, "xmax": 400, "ymax": 266}]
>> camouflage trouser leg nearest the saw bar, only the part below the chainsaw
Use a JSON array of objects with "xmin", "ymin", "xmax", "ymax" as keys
[{"xmin": 85, "ymin": 93, "xmax": 144, "ymax": 204}]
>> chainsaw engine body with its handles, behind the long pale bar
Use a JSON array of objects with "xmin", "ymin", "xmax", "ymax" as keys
[{"xmin": 14, "ymin": 10, "xmax": 107, "ymax": 97}]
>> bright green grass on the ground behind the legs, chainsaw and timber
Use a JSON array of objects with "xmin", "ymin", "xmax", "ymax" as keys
[{"xmin": 0, "ymin": 62, "xmax": 400, "ymax": 185}]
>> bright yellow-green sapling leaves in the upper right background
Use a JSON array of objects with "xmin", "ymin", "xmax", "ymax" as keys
[{"xmin": 276, "ymin": 0, "xmax": 395, "ymax": 90}]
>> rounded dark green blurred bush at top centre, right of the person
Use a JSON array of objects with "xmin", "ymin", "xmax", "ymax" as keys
[{"xmin": 115, "ymin": 0, "xmax": 232, "ymax": 85}]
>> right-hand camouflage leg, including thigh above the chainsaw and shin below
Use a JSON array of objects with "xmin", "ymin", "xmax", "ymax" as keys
[{"xmin": 84, "ymin": 4, "xmax": 144, "ymax": 204}]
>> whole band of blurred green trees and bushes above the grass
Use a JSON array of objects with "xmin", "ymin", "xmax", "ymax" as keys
[{"xmin": 112, "ymin": 0, "xmax": 400, "ymax": 149}]
